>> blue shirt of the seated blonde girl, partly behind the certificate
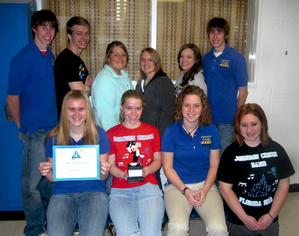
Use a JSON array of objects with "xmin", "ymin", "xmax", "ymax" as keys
[{"xmin": 46, "ymin": 128, "xmax": 110, "ymax": 194}]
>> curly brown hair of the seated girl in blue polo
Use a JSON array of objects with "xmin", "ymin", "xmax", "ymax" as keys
[{"xmin": 174, "ymin": 85, "xmax": 212, "ymax": 126}]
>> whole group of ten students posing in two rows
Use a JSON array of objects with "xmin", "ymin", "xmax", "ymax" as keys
[{"xmin": 8, "ymin": 10, "xmax": 294, "ymax": 236}]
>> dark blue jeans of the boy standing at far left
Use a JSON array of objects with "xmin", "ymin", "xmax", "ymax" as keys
[{"xmin": 22, "ymin": 130, "xmax": 52, "ymax": 236}]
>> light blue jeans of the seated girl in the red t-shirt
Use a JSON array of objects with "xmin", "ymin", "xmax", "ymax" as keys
[{"xmin": 109, "ymin": 183, "xmax": 164, "ymax": 236}]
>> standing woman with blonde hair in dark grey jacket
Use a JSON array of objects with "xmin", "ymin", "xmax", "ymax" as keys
[{"xmin": 136, "ymin": 48, "xmax": 175, "ymax": 135}]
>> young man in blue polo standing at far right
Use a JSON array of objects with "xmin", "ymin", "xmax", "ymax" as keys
[{"xmin": 203, "ymin": 17, "xmax": 248, "ymax": 152}]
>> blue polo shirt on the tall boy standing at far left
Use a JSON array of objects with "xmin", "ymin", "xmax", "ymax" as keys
[{"xmin": 7, "ymin": 42, "xmax": 57, "ymax": 133}]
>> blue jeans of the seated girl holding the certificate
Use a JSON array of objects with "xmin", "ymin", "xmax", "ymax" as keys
[{"xmin": 47, "ymin": 192, "xmax": 108, "ymax": 236}]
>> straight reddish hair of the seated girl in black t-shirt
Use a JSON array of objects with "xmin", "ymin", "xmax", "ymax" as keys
[{"xmin": 234, "ymin": 103, "xmax": 270, "ymax": 146}]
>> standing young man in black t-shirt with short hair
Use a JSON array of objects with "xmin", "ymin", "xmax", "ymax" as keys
[{"xmin": 54, "ymin": 16, "xmax": 91, "ymax": 118}]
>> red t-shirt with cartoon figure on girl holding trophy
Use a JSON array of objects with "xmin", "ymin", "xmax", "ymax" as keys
[{"xmin": 107, "ymin": 123, "xmax": 160, "ymax": 188}]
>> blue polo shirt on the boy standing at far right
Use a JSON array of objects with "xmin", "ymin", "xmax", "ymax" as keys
[{"xmin": 203, "ymin": 45, "xmax": 248, "ymax": 125}]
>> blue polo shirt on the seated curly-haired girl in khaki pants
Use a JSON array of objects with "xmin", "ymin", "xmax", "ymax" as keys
[{"xmin": 161, "ymin": 121, "xmax": 221, "ymax": 184}]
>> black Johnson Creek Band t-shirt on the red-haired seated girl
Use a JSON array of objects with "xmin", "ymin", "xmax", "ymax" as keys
[{"xmin": 217, "ymin": 140, "xmax": 295, "ymax": 224}]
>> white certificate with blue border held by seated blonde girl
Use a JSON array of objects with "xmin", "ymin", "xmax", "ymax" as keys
[{"xmin": 53, "ymin": 145, "xmax": 100, "ymax": 181}]
